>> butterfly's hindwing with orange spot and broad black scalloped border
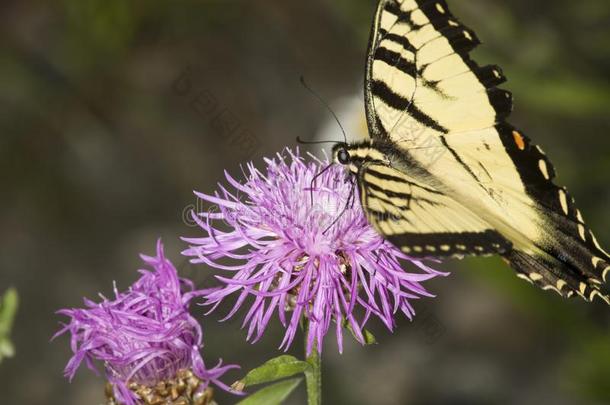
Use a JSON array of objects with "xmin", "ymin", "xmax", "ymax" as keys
[{"xmin": 429, "ymin": 124, "xmax": 610, "ymax": 301}]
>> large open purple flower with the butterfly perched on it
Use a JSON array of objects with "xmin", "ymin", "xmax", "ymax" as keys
[{"xmin": 183, "ymin": 150, "xmax": 446, "ymax": 353}]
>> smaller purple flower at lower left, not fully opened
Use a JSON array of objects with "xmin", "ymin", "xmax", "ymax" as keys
[{"xmin": 54, "ymin": 240, "xmax": 237, "ymax": 405}]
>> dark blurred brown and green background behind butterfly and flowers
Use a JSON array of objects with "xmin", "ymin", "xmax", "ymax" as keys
[{"xmin": 0, "ymin": 0, "xmax": 610, "ymax": 405}]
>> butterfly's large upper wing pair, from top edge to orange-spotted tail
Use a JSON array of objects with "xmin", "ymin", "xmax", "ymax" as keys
[{"xmin": 363, "ymin": 0, "xmax": 610, "ymax": 300}]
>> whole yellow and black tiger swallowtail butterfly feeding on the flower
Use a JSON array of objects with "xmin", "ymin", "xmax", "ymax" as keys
[{"xmin": 333, "ymin": 0, "xmax": 610, "ymax": 304}]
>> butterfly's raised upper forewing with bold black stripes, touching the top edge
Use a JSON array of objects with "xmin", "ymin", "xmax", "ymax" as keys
[{"xmin": 365, "ymin": 0, "xmax": 512, "ymax": 138}]
